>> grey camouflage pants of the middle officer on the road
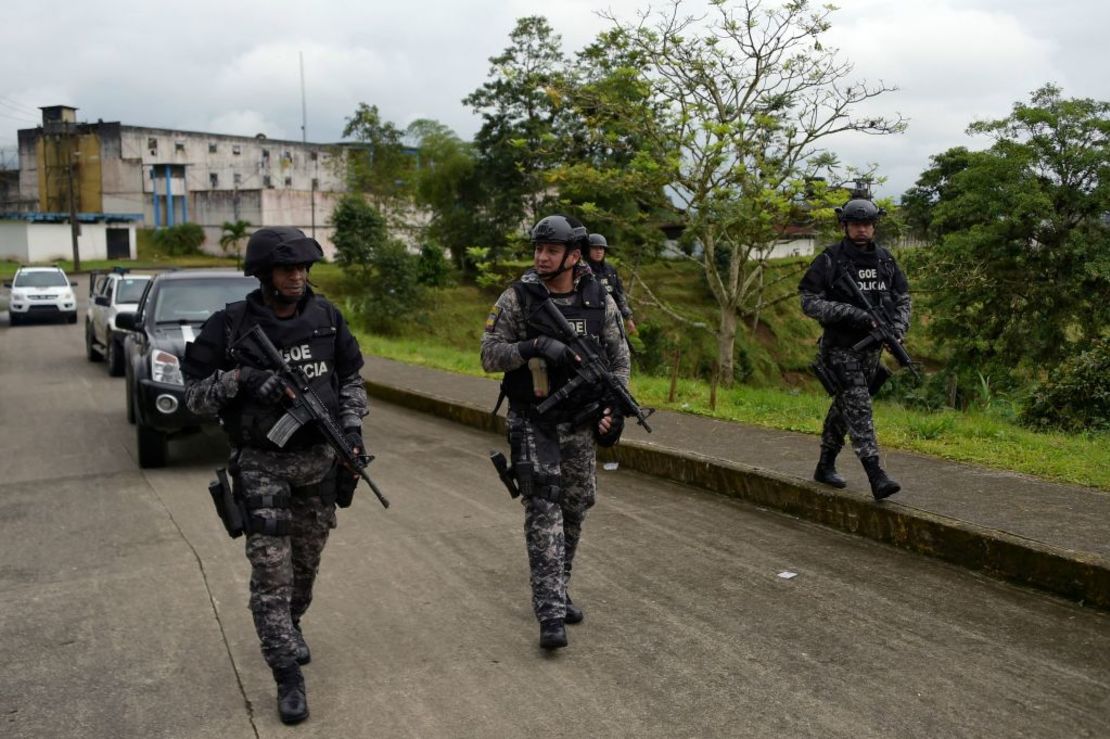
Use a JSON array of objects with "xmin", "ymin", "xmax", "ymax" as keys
[{"xmin": 508, "ymin": 412, "xmax": 597, "ymax": 621}]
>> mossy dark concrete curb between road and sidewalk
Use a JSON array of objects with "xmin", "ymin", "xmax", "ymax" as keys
[{"xmin": 366, "ymin": 381, "xmax": 1110, "ymax": 609}]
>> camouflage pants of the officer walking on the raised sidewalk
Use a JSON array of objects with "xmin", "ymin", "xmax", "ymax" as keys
[{"xmin": 821, "ymin": 346, "xmax": 879, "ymax": 459}]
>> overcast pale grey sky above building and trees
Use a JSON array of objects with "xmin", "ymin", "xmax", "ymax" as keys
[{"xmin": 0, "ymin": 0, "xmax": 1110, "ymax": 198}]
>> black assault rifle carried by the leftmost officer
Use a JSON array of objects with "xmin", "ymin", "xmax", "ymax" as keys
[{"xmin": 232, "ymin": 324, "xmax": 390, "ymax": 508}]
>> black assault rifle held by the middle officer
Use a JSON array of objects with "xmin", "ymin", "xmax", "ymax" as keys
[{"xmin": 527, "ymin": 298, "xmax": 655, "ymax": 433}]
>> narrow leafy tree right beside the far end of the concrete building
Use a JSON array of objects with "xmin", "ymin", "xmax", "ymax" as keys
[{"xmin": 343, "ymin": 102, "xmax": 414, "ymax": 213}]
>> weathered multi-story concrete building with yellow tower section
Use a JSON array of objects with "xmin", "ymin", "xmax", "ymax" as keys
[{"xmin": 8, "ymin": 105, "xmax": 346, "ymax": 258}]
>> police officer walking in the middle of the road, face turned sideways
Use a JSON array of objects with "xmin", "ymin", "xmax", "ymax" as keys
[{"xmin": 482, "ymin": 215, "xmax": 629, "ymax": 649}]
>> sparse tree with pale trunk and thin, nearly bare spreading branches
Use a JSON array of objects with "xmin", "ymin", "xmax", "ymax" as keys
[{"xmin": 594, "ymin": 0, "xmax": 905, "ymax": 383}]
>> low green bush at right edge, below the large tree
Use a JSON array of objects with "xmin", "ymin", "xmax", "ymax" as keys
[{"xmin": 1020, "ymin": 338, "xmax": 1110, "ymax": 432}]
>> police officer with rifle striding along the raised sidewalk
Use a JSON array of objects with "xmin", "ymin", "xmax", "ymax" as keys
[{"xmin": 799, "ymin": 199, "xmax": 910, "ymax": 500}]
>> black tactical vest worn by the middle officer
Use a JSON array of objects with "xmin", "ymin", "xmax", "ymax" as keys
[{"xmin": 501, "ymin": 274, "xmax": 606, "ymax": 421}]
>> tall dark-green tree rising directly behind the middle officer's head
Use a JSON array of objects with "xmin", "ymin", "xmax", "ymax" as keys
[{"xmin": 463, "ymin": 16, "xmax": 572, "ymax": 251}]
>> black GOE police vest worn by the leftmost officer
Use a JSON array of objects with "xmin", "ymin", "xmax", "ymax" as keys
[{"xmin": 220, "ymin": 297, "xmax": 340, "ymax": 449}]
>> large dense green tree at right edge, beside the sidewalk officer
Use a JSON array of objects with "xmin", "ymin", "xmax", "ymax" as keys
[{"xmin": 914, "ymin": 84, "xmax": 1110, "ymax": 386}]
